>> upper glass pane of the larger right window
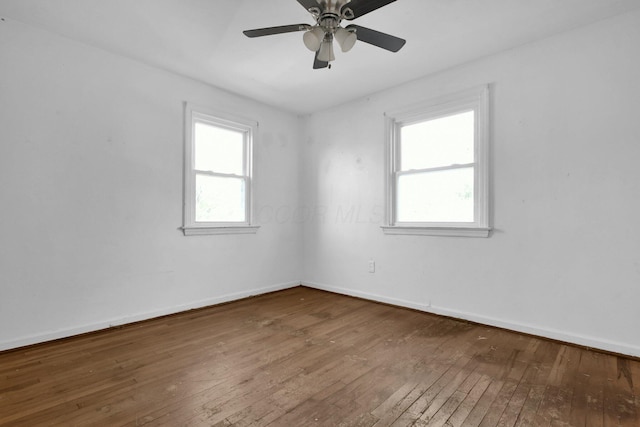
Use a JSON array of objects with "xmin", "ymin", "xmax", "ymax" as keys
[{"xmin": 400, "ymin": 111, "xmax": 475, "ymax": 171}]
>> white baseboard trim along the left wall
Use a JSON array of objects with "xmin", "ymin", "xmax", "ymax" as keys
[{"xmin": 0, "ymin": 281, "xmax": 300, "ymax": 351}]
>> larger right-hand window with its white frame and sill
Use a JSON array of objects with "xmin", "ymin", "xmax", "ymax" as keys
[{"xmin": 383, "ymin": 86, "xmax": 490, "ymax": 237}]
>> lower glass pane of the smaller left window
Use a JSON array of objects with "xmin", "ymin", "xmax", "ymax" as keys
[{"xmin": 195, "ymin": 174, "xmax": 246, "ymax": 222}]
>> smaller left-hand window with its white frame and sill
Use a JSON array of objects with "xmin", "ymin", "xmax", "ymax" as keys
[{"xmin": 183, "ymin": 104, "xmax": 258, "ymax": 235}]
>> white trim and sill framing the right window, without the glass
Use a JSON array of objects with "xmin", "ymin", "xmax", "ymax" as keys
[{"xmin": 382, "ymin": 85, "xmax": 491, "ymax": 237}]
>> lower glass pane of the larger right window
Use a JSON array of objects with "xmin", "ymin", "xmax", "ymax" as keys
[{"xmin": 396, "ymin": 167, "xmax": 474, "ymax": 222}]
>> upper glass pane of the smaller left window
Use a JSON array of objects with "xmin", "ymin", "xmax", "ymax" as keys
[{"xmin": 194, "ymin": 122, "xmax": 244, "ymax": 175}]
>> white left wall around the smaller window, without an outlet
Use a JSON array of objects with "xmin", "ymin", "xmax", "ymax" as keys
[{"xmin": 0, "ymin": 19, "xmax": 301, "ymax": 350}]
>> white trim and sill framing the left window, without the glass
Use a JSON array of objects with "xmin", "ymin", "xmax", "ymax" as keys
[{"xmin": 182, "ymin": 103, "xmax": 260, "ymax": 236}]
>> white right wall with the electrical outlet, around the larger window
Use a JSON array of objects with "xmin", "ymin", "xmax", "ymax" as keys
[{"xmin": 302, "ymin": 12, "xmax": 640, "ymax": 356}]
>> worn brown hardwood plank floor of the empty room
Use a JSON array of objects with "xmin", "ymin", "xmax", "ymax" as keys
[{"xmin": 0, "ymin": 287, "xmax": 640, "ymax": 427}]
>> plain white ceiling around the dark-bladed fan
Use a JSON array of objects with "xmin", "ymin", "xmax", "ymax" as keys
[{"xmin": 0, "ymin": 0, "xmax": 640, "ymax": 114}]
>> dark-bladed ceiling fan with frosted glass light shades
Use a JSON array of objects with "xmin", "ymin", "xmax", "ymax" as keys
[{"xmin": 243, "ymin": 0, "xmax": 406, "ymax": 69}]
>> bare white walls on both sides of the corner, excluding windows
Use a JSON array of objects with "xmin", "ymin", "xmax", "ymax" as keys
[{"xmin": 0, "ymin": 13, "xmax": 640, "ymax": 356}]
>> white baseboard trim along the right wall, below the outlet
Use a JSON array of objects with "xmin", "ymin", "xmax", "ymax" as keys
[{"xmin": 302, "ymin": 281, "xmax": 640, "ymax": 357}]
